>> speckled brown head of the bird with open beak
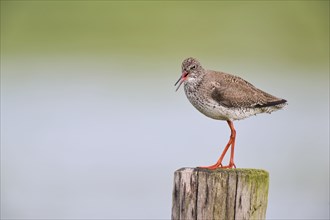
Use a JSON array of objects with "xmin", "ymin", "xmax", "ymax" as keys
[{"xmin": 174, "ymin": 57, "xmax": 203, "ymax": 91}]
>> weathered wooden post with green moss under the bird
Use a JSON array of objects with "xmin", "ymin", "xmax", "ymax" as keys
[{"xmin": 172, "ymin": 168, "xmax": 269, "ymax": 220}]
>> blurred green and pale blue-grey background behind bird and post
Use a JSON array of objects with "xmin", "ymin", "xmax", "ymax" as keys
[{"xmin": 1, "ymin": 1, "xmax": 329, "ymax": 219}]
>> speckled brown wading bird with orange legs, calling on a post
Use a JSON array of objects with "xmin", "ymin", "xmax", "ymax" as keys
[{"xmin": 174, "ymin": 57, "xmax": 287, "ymax": 170}]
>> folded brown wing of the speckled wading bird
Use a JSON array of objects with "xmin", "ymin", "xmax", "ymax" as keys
[{"xmin": 210, "ymin": 73, "xmax": 286, "ymax": 108}]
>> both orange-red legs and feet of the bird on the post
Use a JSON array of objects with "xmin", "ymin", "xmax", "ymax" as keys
[{"xmin": 200, "ymin": 120, "xmax": 236, "ymax": 170}]
